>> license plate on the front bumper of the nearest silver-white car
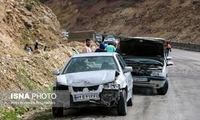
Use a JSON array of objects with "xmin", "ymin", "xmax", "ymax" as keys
[{"xmin": 73, "ymin": 93, "xmax": 100, "ymax": 102}]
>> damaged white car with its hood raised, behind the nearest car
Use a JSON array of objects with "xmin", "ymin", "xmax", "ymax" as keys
[{"xmin": 120, "ymin": 37, "xmax": 173, "ymax": 95}]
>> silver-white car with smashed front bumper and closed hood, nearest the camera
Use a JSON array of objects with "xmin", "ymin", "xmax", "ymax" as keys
[{"xmin": 52, "ymin": 52, "xmax": 133, "ymax": 117}]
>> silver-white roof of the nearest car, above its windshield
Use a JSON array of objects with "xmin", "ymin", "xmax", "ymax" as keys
[{"xmin": 72, "ymin": 52, "xmax": 118, "ymax": 58}]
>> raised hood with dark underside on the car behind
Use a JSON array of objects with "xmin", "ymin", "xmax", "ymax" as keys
[{"xmin": 120, "ymin": 38, "xmax": 165, "ymax": 57}]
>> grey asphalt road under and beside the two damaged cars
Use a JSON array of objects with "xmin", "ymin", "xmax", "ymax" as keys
[{"xmin": 25, "ymin": 49, "xmax": 200, "ymax": 120}]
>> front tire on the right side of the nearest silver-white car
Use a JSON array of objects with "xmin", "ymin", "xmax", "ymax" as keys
[{"xmin": 117, "ymin": 90, "xmax": 127, "ymax": 116}]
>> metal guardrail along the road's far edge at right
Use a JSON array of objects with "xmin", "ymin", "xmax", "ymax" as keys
[{"xmin": 171, "ymin": 42, "xmax": 200, "ymax": 52}]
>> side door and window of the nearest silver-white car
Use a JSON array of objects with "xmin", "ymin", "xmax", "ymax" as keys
[{"xmin": 117, "ymin": 55, "xmax": 133, "ymax": 99}]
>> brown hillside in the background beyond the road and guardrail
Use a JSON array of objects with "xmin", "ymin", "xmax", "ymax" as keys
[{"xmin": 46, "ymin": 0, "xmax": 200, "ymax": 44}]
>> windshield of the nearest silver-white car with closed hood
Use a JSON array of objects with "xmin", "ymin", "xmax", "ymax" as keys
[{"xmin": 63, "ymin": 56, "xmax": 118, "ymax": 74}]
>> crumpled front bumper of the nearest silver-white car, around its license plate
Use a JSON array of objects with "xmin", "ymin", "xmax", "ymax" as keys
[{"xmin": 53, "ymin": 87, "xmax": 120, "ymax": 108}]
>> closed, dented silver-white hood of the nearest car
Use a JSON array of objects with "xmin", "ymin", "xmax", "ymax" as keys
[{"xmin": 57, "ymin": 70, "xmax": 116, "ymax": 87}]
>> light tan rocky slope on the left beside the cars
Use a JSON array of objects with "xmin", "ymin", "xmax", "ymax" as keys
[{"xmin": 0, "ymin": 0, "xmax": 84, "ymax": 90}]
